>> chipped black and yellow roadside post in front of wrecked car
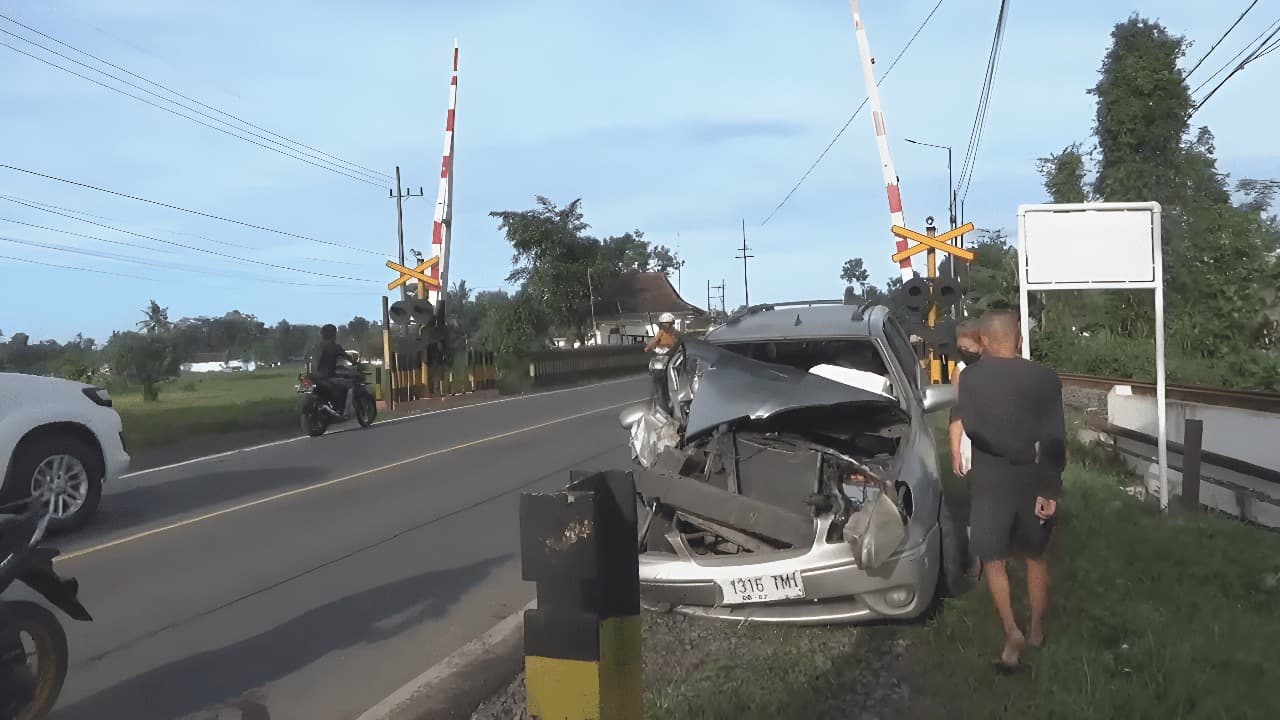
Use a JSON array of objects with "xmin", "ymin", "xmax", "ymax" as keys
[{"xmin": 520, "ymin": 470, "xmax": 644, "ymax": 720}]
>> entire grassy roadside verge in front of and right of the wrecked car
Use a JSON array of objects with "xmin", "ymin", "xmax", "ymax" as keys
[{"xmin": 646, "ymin": 415, "xmax": 1280, "ymax": 720}]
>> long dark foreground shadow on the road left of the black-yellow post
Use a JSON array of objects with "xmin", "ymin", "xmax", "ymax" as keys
[{"xmin": 54, "ymin": 555, "xmax": 511, "ymax": 720}]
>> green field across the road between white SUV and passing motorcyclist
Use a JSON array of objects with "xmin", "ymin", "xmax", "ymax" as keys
[{"xmin": 113, "ymin": 366, "xmax": 301, "ymax": 452}]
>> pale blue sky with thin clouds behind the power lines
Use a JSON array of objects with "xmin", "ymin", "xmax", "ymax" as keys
[{"xmin": 0, "ymin": 0, "xmax": 1280, "ymax": 341}]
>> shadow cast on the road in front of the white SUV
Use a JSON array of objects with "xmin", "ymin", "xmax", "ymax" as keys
[{"xmin": 84, "ymin": 465, "xmax": 324, "ymax": 536}]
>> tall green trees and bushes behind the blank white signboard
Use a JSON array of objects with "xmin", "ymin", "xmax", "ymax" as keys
[{"xmin": 841, "ymin": 17, "xmax": 1280, "ymax": 389}]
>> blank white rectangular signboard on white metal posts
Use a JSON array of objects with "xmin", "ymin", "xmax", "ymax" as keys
[{"xmin": 1018, "ymin": 202, "xmax": 1169, "ymax": 510}]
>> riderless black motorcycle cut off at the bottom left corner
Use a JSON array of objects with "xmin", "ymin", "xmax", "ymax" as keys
[{"xmin": 0, "ymin": 501, "xmax": 93, "ymax": 720}]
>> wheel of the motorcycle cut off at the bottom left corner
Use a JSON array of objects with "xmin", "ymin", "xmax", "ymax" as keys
[{"xmin": 0, "ymin": 600, "xmax": 69, "ymax": 720}]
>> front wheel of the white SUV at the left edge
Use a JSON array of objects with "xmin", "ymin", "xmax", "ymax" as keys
[{"xmin": 14, "ymin": 434, "xmax": 104, "ymax": 532}]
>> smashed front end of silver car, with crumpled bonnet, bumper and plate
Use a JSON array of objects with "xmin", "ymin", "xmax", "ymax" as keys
[{"xmin": 632, "ymin": 343, "xmax": 940, "ymax": 624}]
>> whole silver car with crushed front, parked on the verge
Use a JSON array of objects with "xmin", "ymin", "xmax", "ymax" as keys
[{"xmin": 620, "ymin": 304, "xmax": 961, "ymax": 624}]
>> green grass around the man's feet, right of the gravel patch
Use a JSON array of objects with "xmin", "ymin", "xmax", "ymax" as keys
[{"xmin": 908, "ymin": 415, "xmax": 1280, "ymax": 719}]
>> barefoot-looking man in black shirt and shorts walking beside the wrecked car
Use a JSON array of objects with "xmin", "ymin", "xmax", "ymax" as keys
[{"xmin": 956, "ymin": 311, "xmax": 1066, "ymax": 670}]
